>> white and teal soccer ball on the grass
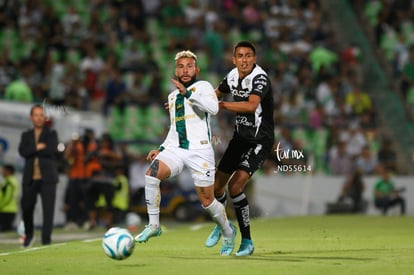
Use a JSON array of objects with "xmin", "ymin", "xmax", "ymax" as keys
[{"xmin": 102, "ymin": 227, "xmax": 135, "ymax": 260}]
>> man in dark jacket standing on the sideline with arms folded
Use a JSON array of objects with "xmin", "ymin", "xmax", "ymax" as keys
[{"xmin": 19, "ymin": 105, "xmax": 58, "ymax": 248}]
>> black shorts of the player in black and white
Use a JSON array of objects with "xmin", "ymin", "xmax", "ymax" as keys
[{"xmin": 217, "ymin": 137, "xmax": 273, "ymax": 177}]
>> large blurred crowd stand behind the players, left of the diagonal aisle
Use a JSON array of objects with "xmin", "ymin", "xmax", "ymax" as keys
[{"xmin": 0, "ymin": 0, "xmax": 404, "ymax": 229}]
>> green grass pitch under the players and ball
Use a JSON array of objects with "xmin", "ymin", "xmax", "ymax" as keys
[{"xmin": 0, "ymin": 216, "xmax": 414, "ymax": 275}]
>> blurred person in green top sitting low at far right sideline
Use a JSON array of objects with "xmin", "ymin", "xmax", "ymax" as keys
[{"xmin": 374, "ymin": 168, "xmax": 406, "ymax": 215}]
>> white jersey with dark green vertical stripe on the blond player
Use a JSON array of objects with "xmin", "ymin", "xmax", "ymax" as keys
[{"xmin": 161, "ymin": 81, "xmax": 219, "ymax": 149}]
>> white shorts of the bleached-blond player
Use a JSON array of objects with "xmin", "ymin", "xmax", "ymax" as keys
[{"xmin": 155, "ymin": 148, "xmax": 216, "ymax": 187}]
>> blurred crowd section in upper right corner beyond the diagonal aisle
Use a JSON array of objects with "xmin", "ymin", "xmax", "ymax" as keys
[{"xmin": 351, "ymin": 0, "xmax": 414, "ymax": 120}]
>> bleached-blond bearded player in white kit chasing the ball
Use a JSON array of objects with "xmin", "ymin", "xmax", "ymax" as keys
[{"xmin": 135, "ymin": 51, "xmax": 236, "ymax": 256}]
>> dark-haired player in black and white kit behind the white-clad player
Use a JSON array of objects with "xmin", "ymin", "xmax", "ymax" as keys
[{"xmin": 206, "ymin": 41, "xmax": 274, "ymax": 256}]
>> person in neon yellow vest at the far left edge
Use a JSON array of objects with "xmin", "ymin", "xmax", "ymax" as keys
[{"xmin": 0, "ymin": 164, "xmax": 19, "ymax": 232}]
